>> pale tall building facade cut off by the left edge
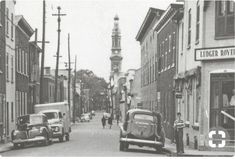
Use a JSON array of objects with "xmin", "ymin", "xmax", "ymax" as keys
[{"xmin": 0, "ymin": 0, "xmax": 16, "ymax": 141}]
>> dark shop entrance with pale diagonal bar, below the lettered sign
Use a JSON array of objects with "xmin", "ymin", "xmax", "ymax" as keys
[{"xmin": 210, "ymin": 73, "xmax": 235, "ymax": 140}]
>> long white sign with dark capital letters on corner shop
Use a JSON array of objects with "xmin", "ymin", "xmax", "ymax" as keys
[{"xmin": 195, "ymin": 46, "xmax": 235, "ymax": 61}]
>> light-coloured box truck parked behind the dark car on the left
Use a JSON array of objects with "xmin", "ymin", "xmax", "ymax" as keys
[{"xmin": 34, "ymin": 102, "xmax": 71, "ymax": 142}]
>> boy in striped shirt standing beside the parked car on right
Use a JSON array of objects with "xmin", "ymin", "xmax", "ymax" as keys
[{"xmin": 174, "ymin": 112, "xmax": 185, "ymax": 154}]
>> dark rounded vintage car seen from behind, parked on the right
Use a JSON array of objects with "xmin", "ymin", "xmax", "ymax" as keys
[{"xmin": 120, "ymin": 109, "xmax": 165, "ymax": 152}]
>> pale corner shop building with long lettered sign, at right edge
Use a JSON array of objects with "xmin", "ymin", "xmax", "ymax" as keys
[{"xmin": 175, "ymin": 0, "xmax": 235, "ymax": 150}]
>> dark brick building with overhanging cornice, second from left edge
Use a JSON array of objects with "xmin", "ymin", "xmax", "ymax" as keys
[{"xmin": 15, "ymin": 15, "xmax": 34, "ymax": 117}]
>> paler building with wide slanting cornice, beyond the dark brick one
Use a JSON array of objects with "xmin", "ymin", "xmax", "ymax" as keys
[{"xmin": 136, "ymin": 8, "xmax": 164, "ymax": 110}]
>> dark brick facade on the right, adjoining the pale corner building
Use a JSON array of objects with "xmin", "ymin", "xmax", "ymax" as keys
[{"xmin": 157, "ymin": 20, "xmax": 177, "ymax": 138}]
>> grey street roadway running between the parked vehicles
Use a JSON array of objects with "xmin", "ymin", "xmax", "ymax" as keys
[{"xmin": 1, "ymin": 113, "xmax": 167, "ymax": 157}]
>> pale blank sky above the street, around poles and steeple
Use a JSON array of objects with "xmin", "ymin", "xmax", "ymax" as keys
[{"xmin": 16, "ymin": 0, "xmax": 175, "ymax": 80}]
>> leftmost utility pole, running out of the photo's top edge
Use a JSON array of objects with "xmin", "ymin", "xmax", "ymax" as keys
[{"xmin": 40, "ymin": 0, "xmax": 46, "ymax": 104}]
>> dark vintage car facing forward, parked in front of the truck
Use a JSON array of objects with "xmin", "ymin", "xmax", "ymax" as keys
[{"xmin": 11, "ymin": 114, "xmax": 52, "ymax": 148}]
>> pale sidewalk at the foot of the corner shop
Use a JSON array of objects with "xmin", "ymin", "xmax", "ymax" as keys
[{"xmin": 164, "ymin": 138, "xmax": 235, "ymax": 157}]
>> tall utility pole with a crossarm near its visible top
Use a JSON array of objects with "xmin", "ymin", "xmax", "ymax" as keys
[{"xmin": 52, "ymin": 6, "xmax": 66, "ymax": 102}]
